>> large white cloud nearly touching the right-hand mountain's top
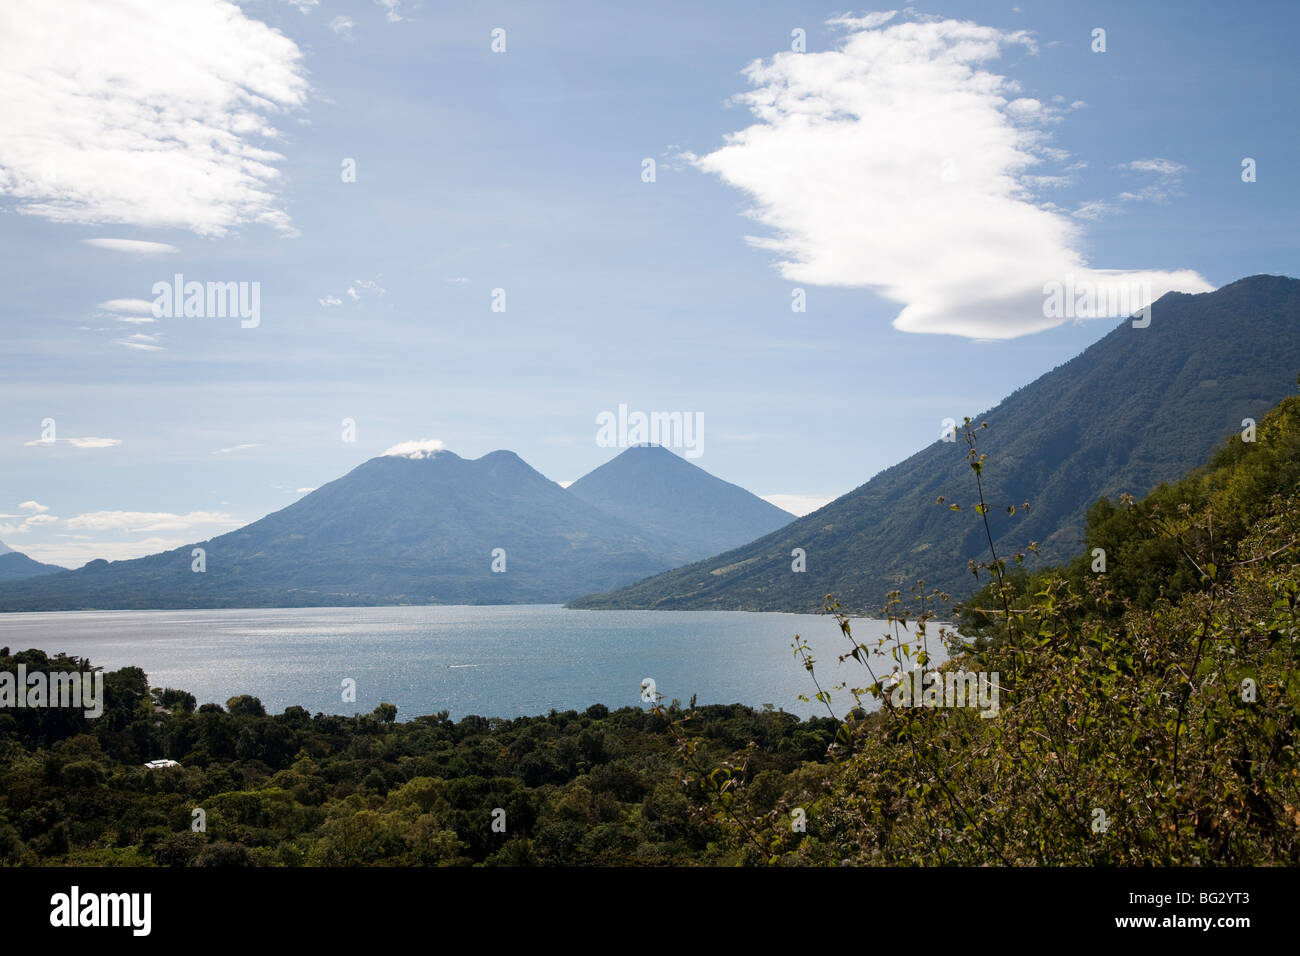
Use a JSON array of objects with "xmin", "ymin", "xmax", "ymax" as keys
[{"xmin": 689, "ymin": 14, "xmax": 1213, "ymax": 338}]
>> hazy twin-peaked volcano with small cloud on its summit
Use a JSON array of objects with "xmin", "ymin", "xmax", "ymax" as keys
[{"xmin": 0, "ymin": 451, "xmax": 672, "ymax": 610}]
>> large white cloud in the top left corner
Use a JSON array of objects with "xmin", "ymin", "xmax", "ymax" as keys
[{"xmin": 0, "ymin": 0, "xmax": 308, "ymax": 235}]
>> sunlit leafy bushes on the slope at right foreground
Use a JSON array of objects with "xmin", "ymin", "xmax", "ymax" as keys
[{"xmin": 696, "ymin": 398, "xmax": 1300, "ymax": 865}]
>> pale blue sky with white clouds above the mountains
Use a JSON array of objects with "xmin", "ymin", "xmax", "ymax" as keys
[{"xmin": 0, "ymin": 0, "xmax": 1300, "ymax": 567}]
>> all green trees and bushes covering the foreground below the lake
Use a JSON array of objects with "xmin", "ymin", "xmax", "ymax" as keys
[{"xmin": 0, "ymin": 397, "xmax": 1300, "ymax": 866}]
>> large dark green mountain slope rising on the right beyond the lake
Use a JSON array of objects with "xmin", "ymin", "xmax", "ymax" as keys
[{"xmin": 571, "ymin": 276, "xmax": 1300, "ymax": 613}]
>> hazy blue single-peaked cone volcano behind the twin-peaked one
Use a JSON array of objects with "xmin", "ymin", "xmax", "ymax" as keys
[{"xmin": 568, "ymin": 445, "xmax": 794, "ymax": 564}]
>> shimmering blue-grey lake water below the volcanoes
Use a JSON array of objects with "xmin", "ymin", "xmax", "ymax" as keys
[{"xmin": 0, "ymin": 605, "xmax": 941, "ymax": 719}]
